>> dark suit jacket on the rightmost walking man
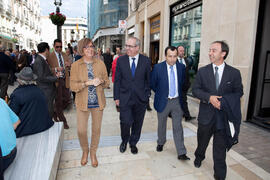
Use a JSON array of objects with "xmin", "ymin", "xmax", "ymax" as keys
[{"xmin": 192, "ymin": 63, "xmax": 243, "ymax": 125}]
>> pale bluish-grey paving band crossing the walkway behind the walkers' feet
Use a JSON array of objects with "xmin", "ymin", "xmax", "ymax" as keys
[{"xmin": 62, "ymin": 128, "xmax": 196, "ymax": 151}]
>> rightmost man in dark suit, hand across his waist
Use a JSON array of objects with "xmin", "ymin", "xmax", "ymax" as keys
[{"xmin": 192, "ymin": 41, "xmax": 243, "ymax": 179}]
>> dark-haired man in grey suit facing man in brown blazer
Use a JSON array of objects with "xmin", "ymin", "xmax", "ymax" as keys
[{"xmin": 33, "ymin": 42, "xmax": 58, "ymax": 117}]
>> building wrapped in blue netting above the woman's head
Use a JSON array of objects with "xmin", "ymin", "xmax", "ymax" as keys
[{"xmin": 87, "ymin": 0, "xmax": 128, "ymax": 51}]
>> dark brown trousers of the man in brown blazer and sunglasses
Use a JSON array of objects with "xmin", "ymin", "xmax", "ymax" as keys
[{"xmin": 54, "ymin": 78, "xmax": 71, "ymax": 123}]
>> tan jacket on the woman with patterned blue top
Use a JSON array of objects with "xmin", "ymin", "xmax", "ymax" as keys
[{"xmin": 70, "ymin": 58, "xmax": 110, "ymax": 111}]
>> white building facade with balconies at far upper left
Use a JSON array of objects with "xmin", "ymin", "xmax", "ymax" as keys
[{"xmin": 0, "ymin": 0, "xmax": 41, "ymax": 50}]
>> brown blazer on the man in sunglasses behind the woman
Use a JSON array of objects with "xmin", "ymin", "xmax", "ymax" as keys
[{"xmin": 48, "ymin": 51, "xmax": 70, "ymax": 88}]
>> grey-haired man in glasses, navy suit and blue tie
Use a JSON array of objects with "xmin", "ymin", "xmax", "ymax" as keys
[{"xmin": 114, "ymin": 37, "xmax": 151, "ymax": 154}]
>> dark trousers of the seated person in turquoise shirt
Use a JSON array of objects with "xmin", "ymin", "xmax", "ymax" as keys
[{"xmin": 0, "ymin": 147, "xmax": 17, "ymax": 180}]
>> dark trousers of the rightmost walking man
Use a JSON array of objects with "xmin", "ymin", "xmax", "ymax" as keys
[{"xmin": 195, "ymin": 121, "xmax": 227, "ymax": 179}]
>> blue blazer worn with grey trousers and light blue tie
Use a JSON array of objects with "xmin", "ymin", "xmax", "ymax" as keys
[{"xmin": 151, "ymin": 61, "xmax": 185, "ymax": 112}]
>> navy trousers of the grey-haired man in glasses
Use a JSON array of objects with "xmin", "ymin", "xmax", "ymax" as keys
[{"xmin": 120, "ymin": 97, "xmax": 147, "ymax": 146}]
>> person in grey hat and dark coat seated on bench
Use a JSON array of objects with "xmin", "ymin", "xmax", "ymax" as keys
[{"xmin": 9, "ymin": 67, "xmax": 54, "ymax": 138}]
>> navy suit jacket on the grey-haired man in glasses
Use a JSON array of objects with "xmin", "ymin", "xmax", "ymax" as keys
[{"xmin": 113, "ymin": 54, "xmax": 151, "ymax": 107}]
